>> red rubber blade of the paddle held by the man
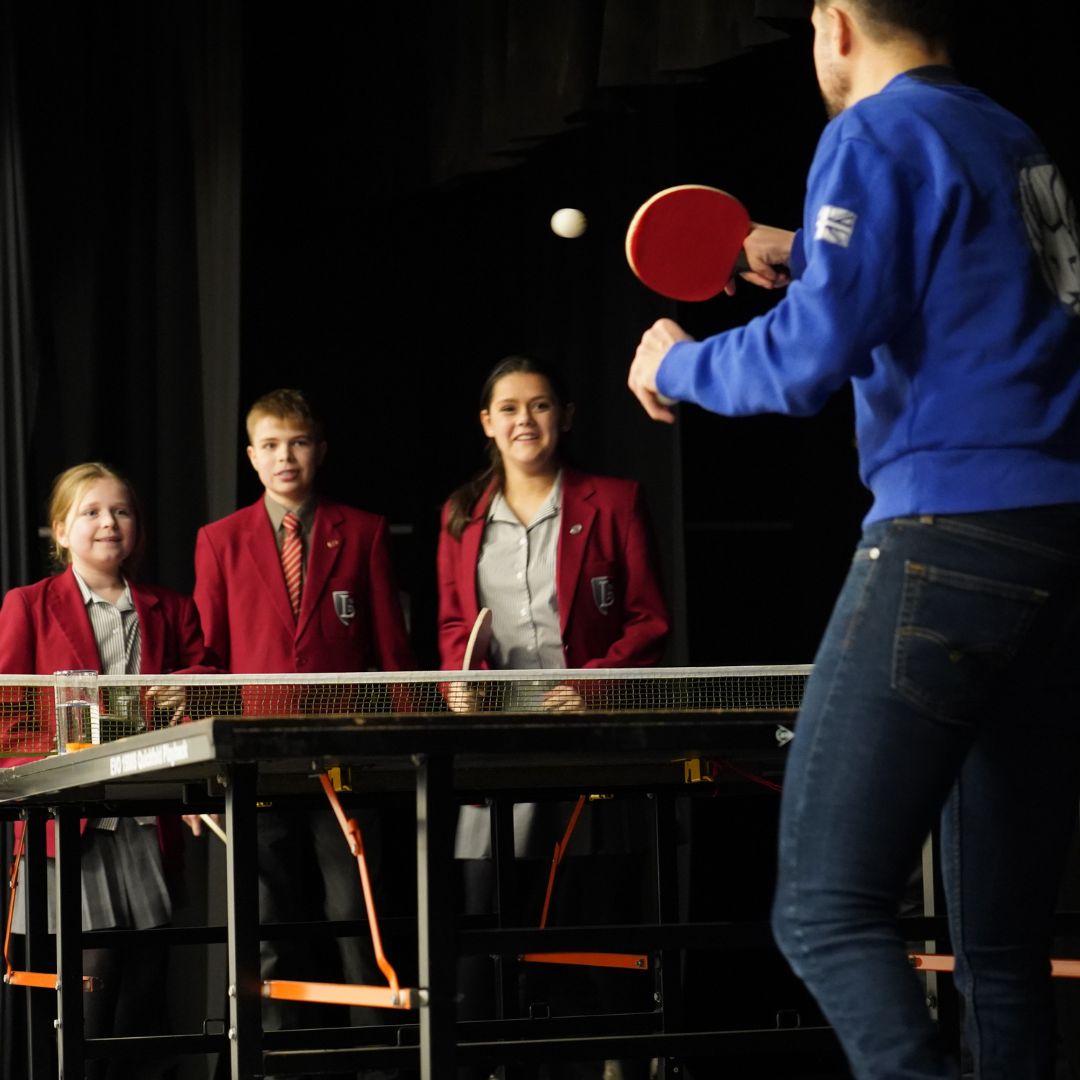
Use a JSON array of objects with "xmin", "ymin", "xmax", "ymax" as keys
[{"xmin": 626, "ymin": 184, "xmax": 751, "ymax": 300}]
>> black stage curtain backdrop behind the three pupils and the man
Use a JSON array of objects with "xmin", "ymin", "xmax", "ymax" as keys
[{"xmin": 0, "ymin": 0, "xmax": 1080, "ymax": 1078}]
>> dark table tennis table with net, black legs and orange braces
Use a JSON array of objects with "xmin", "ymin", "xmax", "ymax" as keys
[{"xmin": 0, "ymin": 665, "xmax": 859, "ymax": 1080}]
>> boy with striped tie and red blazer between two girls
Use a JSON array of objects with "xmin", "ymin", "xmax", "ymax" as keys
[{"xmin": 194, "ymin": 390, "xmax": 415, "ymax": 1054}]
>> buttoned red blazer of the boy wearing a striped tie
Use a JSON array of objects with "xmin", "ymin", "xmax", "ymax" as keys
[{"xmin": 194, "ymin": 496, "xmax": 416, "ymax": 675}]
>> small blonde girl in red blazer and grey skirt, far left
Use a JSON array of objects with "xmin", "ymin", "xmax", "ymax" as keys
[{"xmin": 0, "ymin": 462, "xmax": 215, "ymax": 1077}]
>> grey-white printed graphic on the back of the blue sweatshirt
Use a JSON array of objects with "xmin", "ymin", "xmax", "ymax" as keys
[{"xmin": 1020, "ymin": 161, "xmax": 1080, "ymax": 315}]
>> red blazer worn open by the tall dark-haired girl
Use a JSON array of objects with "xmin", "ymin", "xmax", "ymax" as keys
[{"xmin": 438, "ymin": 469, "xmax": 669, "ymax": 671}]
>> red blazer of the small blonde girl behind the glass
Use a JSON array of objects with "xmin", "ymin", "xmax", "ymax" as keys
[{"xmin": 0, "ymin": 568, "xmax": 219, "ymax": 855}]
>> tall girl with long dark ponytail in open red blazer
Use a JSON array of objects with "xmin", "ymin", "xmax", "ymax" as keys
[{"xmin": 438, "ymin": 356, "xmax": 667, "ymax": 1080}]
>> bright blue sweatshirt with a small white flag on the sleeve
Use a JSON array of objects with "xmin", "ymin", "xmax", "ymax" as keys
[{"xmin": 657, "ymin": 68, "xmax": 1080, "ymax": 523}]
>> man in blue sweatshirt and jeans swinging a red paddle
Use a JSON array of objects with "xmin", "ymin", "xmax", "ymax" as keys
[{"xmin": 630, "ymin": 0, "xmax": 1080, "ymax": 1080}]
